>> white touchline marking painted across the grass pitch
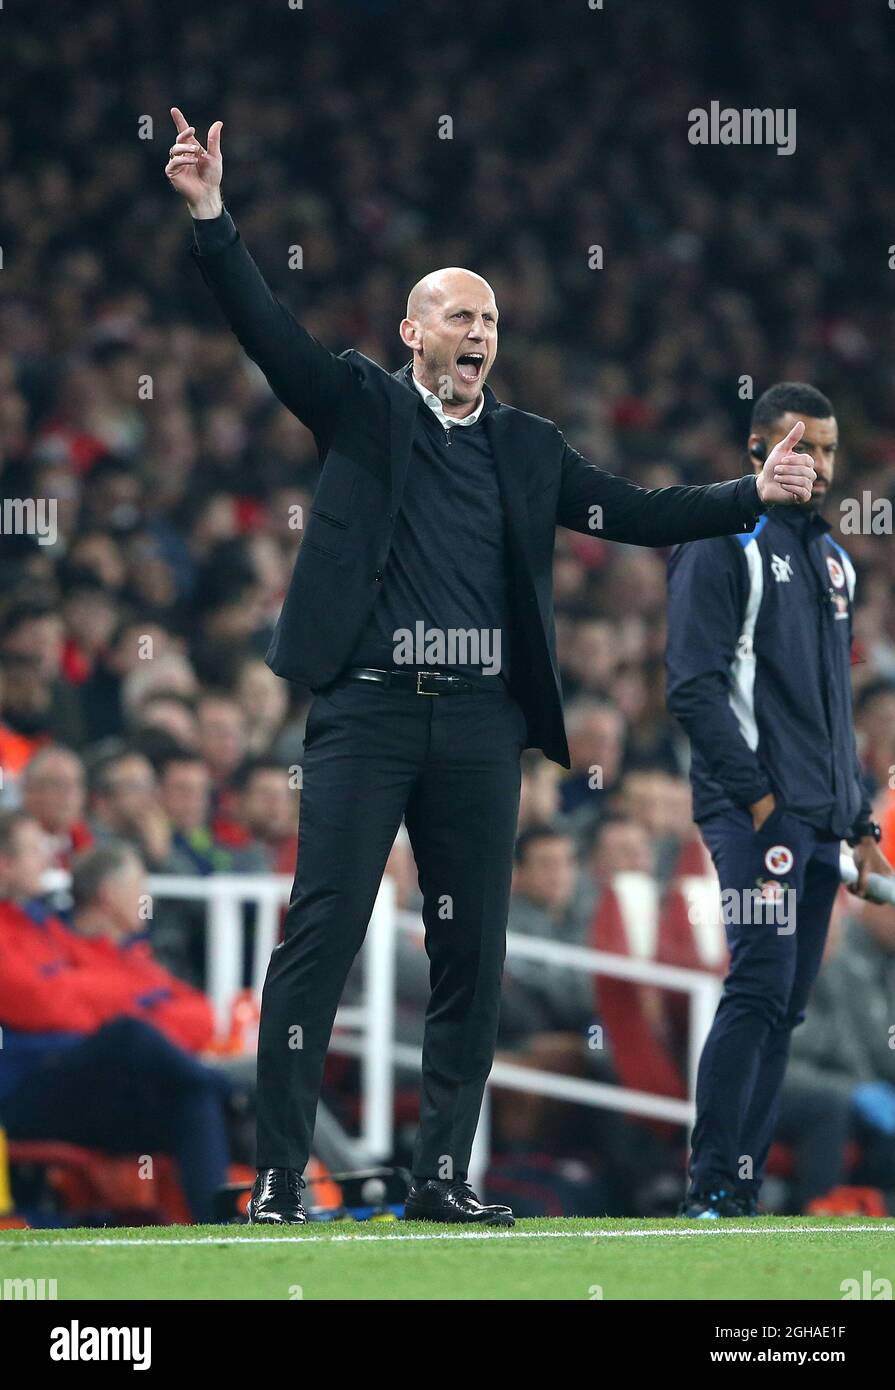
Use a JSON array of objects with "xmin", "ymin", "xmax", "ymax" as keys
[{"xmin": 0, "ymin": 1222, "xmax": 895, "ymax": 1252}]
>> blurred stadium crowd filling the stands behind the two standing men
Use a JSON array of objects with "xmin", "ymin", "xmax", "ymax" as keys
[{"xmin": 0, "ymin": 0, "xmax": 895, "ymax": 1215}]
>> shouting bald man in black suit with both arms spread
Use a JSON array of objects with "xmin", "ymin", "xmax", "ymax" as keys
[{"xmin": 165, "ymin": 108, "xmax": 814, "ymax": 1226}]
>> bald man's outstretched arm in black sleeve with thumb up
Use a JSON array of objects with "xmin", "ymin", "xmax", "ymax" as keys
[{"xmin": 556, "ymin": 420, "xmax": 816, "ymax": 546}]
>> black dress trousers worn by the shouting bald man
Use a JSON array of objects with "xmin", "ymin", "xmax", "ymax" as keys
[{"xmin": 257, "ymin": 677, "xmax": 525, "ymax": 1180}]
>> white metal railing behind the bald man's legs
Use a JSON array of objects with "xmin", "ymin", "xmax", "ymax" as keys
[{"xmin": 149, "ymin": 874, "xmax": 720, "ymax": 1182}]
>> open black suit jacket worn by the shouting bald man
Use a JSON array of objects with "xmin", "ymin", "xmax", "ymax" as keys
[{"xmin": 193, "ymin": 222, "xmax": 762, "ymax": 767}]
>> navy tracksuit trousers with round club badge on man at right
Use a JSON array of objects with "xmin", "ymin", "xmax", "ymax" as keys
[{"xmin": 689, "ymin": 809, "xmax": 839, "ymax": 1197}]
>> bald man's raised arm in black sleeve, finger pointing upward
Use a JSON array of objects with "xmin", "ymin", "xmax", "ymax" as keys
[{"xmin": 165, "ymin": 107, "xmax": 356, "ymax": 448}]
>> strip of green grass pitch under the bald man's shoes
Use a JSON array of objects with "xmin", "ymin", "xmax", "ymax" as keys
[{"xmin": 0, "ymin": 1216, "xmax": 895, "ymax": 1300}]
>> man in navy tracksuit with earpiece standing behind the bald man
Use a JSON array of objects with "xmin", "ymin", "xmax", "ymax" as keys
[{"xmin": 667, "ymin": 382, "xmax": 892, "ymax": 1218}]
